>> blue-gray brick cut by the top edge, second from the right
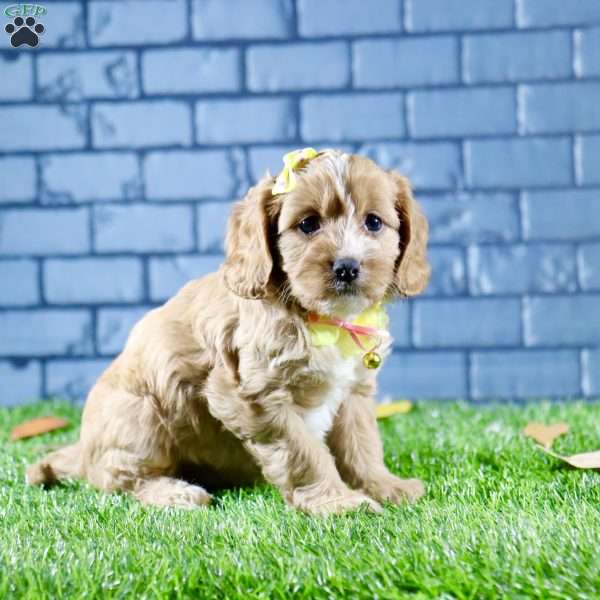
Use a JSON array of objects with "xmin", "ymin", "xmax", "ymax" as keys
[{"xmin": 404, "ymin": 0, "xmax": 513, "ymax": 31}]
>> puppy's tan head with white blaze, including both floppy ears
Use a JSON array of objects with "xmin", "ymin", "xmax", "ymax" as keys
[{"xmin": 224, "ymin": 150, "xmax": 430, "ymax": 316}]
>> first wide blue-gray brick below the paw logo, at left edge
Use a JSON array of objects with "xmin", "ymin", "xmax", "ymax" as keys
[{"xmin": 0, "ymin": 105, "xmax": 87, "ymax": 152}]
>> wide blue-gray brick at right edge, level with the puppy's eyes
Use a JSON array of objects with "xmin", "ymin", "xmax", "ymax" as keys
[{"xmin": 522, "ymin": 190, "xmax": 600, "ymax": 240}]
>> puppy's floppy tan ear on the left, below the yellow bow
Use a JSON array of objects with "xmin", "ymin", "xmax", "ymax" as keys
[{"xmin": 223, "ymin": 176, "xmax": 275, "ymax": 299}]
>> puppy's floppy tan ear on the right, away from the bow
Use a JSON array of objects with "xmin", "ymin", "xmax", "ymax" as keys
[{"xmin": 389, "ymin": 171, "xmax": 431, "ymax": 296}]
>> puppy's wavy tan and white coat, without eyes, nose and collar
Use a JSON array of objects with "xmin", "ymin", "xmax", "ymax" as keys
[{"xmin": 27, "ymin": 150, "xmax": 429, "ymax": 514}]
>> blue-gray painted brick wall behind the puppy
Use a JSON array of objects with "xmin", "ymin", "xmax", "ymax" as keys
[{"xmin": 0, "ymin": 0, "xmax": 600, "ymax": 404}]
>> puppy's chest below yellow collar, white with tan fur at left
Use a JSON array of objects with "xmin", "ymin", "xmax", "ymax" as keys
[{"xmin": 295, "ymin": 348, "xmax": 364, "ymax": 439}]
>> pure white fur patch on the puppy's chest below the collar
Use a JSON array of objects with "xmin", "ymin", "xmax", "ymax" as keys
[{"xmin": 304, "ymin": 348, "xmax": 359, "ymax": 440}]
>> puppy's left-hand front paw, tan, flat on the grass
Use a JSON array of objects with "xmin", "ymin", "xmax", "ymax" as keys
[{"xmin": 292, "ymin": 486, "xmax": 381, "ymax": 515}]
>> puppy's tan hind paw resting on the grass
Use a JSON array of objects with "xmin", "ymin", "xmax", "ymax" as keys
[{"xmin": 133, "ymin": 477, "xmax": 212, "ymax": 508}]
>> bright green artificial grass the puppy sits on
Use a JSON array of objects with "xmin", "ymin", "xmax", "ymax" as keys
[{"xmin": 0, "ymin": 403, "xmax": 600, "ymax": 599}]
